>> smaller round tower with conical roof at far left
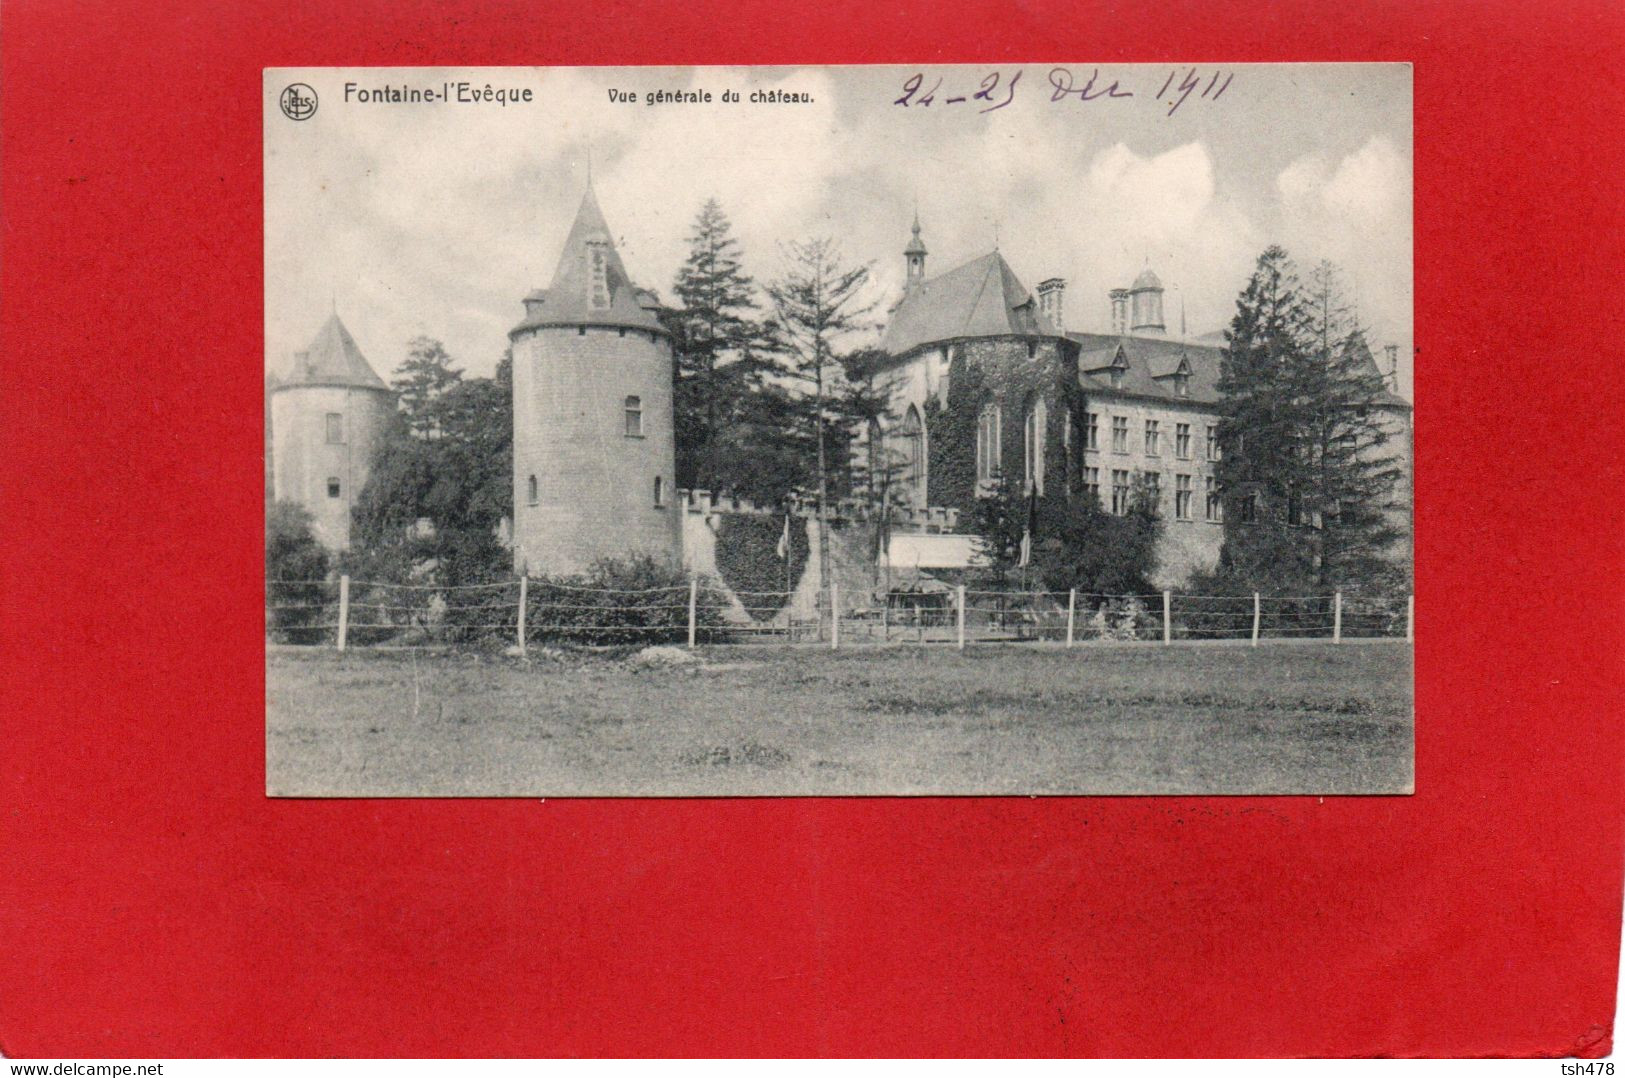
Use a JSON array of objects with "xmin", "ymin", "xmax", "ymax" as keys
[{"xmin": 268, "ymin": 314, "xmax": 395, "ymax": 551}]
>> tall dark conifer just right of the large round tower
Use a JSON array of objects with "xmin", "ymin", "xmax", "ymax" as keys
[{"xmin": 666, "ymin": 198, "xmax": 770, "ymax": 489}]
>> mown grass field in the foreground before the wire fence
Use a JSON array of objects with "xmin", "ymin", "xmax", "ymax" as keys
[{"xmin": 267, "ymin": 642, "xmax": 1412, "ymax": 797}]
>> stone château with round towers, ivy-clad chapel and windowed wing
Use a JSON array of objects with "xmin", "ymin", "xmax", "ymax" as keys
[{"xmin": 270, "ymin": 184, "xmax": 1411, "ymax": 590}]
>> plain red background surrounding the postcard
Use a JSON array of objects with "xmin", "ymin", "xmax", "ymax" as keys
[{"xmin": 0, "ymin": 0, "xmax": 1625, "ymax": 1057}]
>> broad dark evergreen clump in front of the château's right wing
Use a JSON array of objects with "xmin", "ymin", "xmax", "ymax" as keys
[{"xmin": 1217, "ymin": 246, "xmax": 1398, "ymax": 593}]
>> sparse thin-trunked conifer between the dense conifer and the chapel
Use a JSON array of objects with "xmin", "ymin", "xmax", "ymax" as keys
[{"xmin": 767, "ymin": 239, "xmax": 874, "ymax": 585}]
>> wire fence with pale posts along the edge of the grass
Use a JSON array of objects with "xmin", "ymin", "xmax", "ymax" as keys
[{"xmin": 265, "ymin": 576, "xmax": 1415, "ymax": 652}]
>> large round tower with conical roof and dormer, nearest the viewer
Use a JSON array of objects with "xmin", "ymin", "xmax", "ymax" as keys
[{"xmin": 509, "ymin": 185, "xmax": 681, "ymax": 574}]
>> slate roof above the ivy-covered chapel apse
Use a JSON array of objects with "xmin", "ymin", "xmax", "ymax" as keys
[{"xmin": 881, "ymin": 250, "xmax": 1056, "ymax": 356}]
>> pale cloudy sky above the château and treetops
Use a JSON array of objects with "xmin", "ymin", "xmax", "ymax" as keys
[{"xmin": 265, "ymin": 63, "xmax": 1412, "ymax": 395}]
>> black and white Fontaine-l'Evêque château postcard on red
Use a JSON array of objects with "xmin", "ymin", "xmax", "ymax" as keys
[{"xmin": 263, "ymin": 62, "xmax": 1415, "ymax": 797}]
